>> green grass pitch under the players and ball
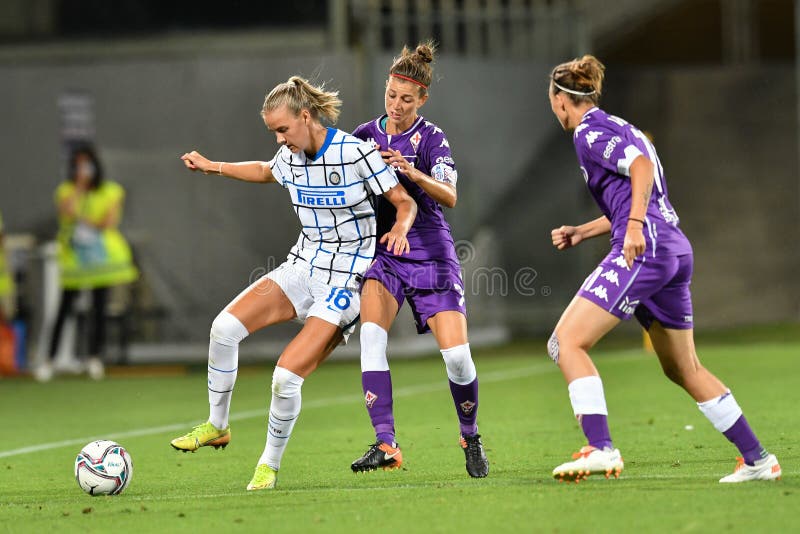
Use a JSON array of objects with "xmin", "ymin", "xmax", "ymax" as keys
[{"xmin": 0, "ymin": 341, "xmax": 800, "ymax": 533}]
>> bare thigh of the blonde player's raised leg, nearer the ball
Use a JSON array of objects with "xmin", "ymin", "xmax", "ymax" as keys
[{"xmin": 225, "ymin": 277, "xmax": 296, "ymax": 334}]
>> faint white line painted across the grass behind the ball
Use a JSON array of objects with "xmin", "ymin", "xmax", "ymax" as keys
[{"xmin": 0, "ymin": 362, "xmax": 558, "ymax": 458}]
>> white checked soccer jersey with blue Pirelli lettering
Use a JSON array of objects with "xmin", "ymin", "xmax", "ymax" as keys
[{"xmin": 269, "ymin": 128, "xmax": 398, "ymax": 289}]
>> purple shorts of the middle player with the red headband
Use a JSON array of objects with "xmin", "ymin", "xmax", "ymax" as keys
[{"xmin": 364, "ymin": 254, "xmax": 467, "ymax": 334}]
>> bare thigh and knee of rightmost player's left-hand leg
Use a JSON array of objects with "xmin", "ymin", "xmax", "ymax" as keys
[{"xmin": 553, "ymin": 296, "xmax": 620, "ymax": 383}]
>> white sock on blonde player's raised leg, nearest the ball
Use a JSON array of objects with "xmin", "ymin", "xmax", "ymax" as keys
[{"xmin": 208, "ymin": 311, "xmax": 249, "ymax": 429}]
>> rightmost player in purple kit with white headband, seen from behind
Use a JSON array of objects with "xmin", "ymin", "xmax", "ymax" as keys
[{"xmin": 547, "ymin": 55, "xmax": 781, "ymax": 482}]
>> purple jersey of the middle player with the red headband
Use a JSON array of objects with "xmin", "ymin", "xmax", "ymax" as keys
[{"xmin": 353, "ymin": 115, "xmax": 458, "ymax": 263}]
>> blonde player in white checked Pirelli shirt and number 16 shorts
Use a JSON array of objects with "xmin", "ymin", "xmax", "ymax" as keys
[{"xmin": 172, "ymin": 76, "xmax": 417, "ymax": 490}]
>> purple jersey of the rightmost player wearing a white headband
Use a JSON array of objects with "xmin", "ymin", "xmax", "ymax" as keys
[{"xmin": 573, "ymin": 107, "xmax": 692, "ymax": 258}]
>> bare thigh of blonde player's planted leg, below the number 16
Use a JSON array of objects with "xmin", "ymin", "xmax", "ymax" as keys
[{"xmin": 278, "ymin": 316, "xmax": 342, "ymax": 378}]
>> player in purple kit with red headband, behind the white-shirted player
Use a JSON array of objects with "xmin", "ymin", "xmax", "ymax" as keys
[{"xmin": 351, "ymin": 43, "xmax": 489, "ymax": 477}]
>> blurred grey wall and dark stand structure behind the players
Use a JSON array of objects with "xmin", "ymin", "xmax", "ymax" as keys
[{"xmin": 0, "ymin": 0, "xmax": 800, "ymax": 365}]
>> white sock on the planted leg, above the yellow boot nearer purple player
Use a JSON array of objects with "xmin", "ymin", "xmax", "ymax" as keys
[{"xmin": 258, "ymin": 367, "xmax": 303, "ymax": 471}]
